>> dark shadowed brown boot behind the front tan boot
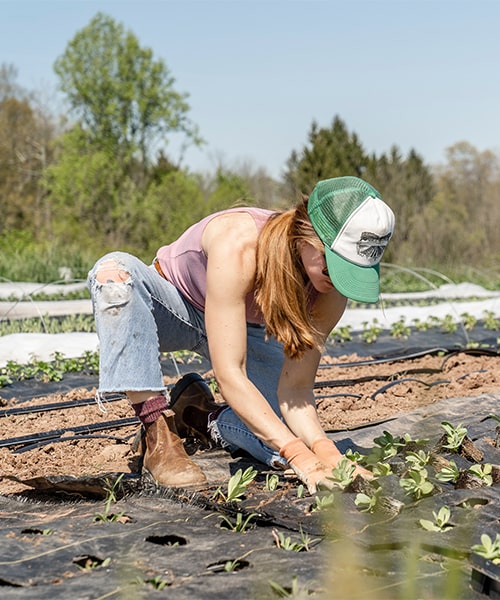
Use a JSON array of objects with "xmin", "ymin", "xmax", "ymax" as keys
[{"xmin": 169, "ymin": 373, "xmax": 226, "ymax": 446}]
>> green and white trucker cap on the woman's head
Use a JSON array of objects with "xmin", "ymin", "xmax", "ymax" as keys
[{"xmin": 307, "ymin": 177, "xmax": 395, "ymax": 302}]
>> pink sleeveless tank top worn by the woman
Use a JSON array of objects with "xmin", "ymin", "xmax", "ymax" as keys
[{"xmin": 156, "ymin": 207, "xmax": 274, "ymax": 324}]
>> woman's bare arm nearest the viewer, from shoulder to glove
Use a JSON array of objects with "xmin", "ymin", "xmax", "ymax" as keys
[{"xmin": 203, "ymin": 213, "xmax": 295, "ymax": 450}]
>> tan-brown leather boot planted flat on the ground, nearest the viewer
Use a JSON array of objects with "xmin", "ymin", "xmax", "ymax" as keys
[{"xmin": 143, "ymin": 410, "xmax": 207, "ymax": 487}]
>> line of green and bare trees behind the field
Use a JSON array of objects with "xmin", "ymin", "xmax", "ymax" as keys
[{"xmin": 0, "ymin": 13, "xmax": 500, "ymax": 282}]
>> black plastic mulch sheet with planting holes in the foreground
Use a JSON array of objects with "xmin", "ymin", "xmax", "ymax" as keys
[{"xmin": 0, "ymin": 332, "xmax": 500, "ymax": 600}]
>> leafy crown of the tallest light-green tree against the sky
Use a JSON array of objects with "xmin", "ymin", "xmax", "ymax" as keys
[{"xmin": 54, "ymin": 13, "xmax": 201, "ymax": 164}]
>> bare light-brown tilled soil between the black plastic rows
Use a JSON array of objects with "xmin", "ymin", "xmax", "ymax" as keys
[{"xmin": 0, "ymin": 352, "xmax": 500, "ymax": 495}]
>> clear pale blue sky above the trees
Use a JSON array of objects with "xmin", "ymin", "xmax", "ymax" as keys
[{"xmin": 0, "ymin": 0, "xmax": 500, "ymax": 177}]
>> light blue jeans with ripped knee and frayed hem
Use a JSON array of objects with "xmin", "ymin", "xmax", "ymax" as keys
[{"xmin": 88, "ymin": 252, "xmax": 286, "ymax": 467}]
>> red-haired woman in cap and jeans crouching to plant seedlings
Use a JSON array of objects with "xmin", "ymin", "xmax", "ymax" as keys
[{"xmin": 89, "ymin": 177, "xmax": 394, "ymax": 493}]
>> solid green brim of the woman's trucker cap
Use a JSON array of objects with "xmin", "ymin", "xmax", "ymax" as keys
[{"xmin": 325, "ymin": 247, "xmax": 380, "ymax": 302}]
